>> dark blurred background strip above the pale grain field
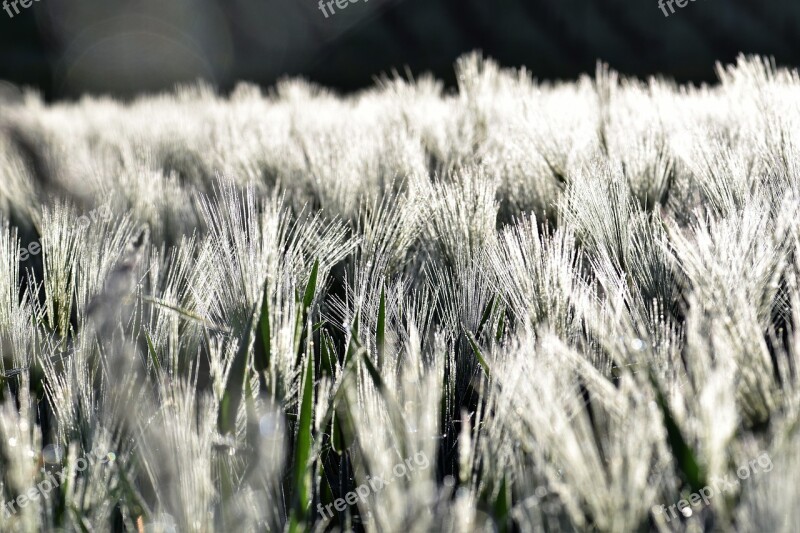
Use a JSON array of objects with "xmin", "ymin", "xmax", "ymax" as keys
[{"xmin": 0, "ymin": 0, "xmax": 800, "ymax": 100}]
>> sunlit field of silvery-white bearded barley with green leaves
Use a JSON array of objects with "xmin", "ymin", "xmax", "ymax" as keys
[{"xmin": 0, "ymin": 55, "xmax": 800, "ymax": 532}]
